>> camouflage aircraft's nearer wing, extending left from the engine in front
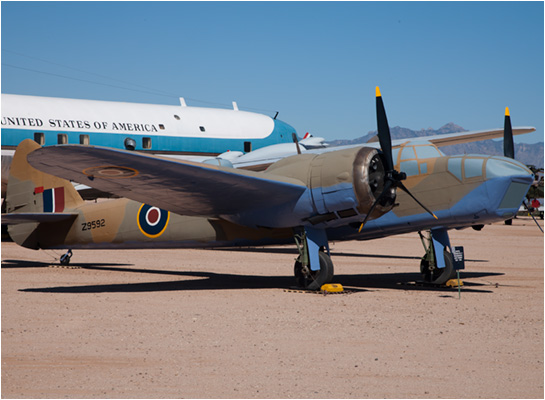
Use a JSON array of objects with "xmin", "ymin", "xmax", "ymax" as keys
[{"xmin": 28, "ymin": 145, "xmax": 307, "ymax": 216}]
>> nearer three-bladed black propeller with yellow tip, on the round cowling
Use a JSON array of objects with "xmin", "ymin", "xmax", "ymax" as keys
[{"xmin": 358, "ymin": 86, "xmax": 438, "ymax": 232}]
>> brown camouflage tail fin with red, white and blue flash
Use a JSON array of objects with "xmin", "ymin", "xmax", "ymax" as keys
[{"xmin": 6, "ymin": 139, "xmax": 84, "ymax": 249}]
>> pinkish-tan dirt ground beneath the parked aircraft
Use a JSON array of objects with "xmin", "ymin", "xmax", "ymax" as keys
[{"xmin": 2, "ymin": 219, "xmax": 544, "ymax": 398}]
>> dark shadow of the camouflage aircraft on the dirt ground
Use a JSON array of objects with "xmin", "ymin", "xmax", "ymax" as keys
[{"xmin": 15, "ymin": 264, "xmax": 503, "ymax": 293}]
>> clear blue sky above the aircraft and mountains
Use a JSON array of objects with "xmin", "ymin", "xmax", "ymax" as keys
[{"xmin": 1, "ymin": 2, "xmax": 544, "ymax": 143}]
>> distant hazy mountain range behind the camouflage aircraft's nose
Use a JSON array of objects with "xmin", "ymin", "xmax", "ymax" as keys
[{"xmin": 327, "ymin": 122, "xmax": 544, "ymax": 168}]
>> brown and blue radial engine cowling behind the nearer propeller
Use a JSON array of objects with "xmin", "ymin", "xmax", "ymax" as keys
[{"xmin": 267, "ymin": 147, "xmax": 396, "ymax": 224}]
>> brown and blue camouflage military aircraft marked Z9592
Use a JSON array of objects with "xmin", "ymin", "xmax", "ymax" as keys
[{"xmin": 2, "ymin": 88, "xmax": 535, "ymax": 289}]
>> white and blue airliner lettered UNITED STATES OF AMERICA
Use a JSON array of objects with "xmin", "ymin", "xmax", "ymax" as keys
[{"xmin": 1, "ymin": 94, "xmax": 296, "ymax": 193}]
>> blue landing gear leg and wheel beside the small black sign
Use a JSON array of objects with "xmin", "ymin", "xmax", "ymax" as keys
[{"xmin": 418, "ymin": 229, "xmax": 456, "ymax": 285}]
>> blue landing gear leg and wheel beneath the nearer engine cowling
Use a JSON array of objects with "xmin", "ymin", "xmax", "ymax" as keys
[{"xmin": 293, "ymin": 228, "xmax": 333, "ymax": 290}]
